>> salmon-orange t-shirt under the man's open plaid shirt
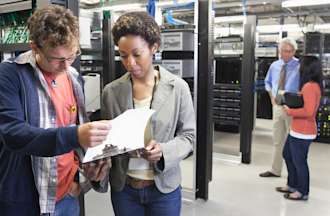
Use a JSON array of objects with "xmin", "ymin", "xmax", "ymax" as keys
[{"xmin": 43, "ymin": 71, "xmax": 79, "ymax": 201}]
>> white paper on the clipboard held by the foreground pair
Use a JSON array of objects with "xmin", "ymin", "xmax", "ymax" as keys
[{"xmin": 83, "ymin": 108, "xmax": 155, "ymax": 163}]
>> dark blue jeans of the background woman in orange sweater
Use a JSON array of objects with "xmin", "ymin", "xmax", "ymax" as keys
[{"xmin": 283, "ymin": 135, "xmax": 312, "ymax": 195}]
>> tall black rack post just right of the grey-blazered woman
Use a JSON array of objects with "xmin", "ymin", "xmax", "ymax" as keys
[{"xmin": 196, "ymin": 0, "xmax": 214, "ymax": 200}]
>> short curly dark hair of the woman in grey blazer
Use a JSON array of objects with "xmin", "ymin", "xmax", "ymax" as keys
[{"xmin": 112, "ymin": 12, "xmax": 160, "ymax": 46}]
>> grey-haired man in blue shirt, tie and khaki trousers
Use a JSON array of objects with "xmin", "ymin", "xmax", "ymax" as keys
[{"xmin": 259, "ymin": 38, "xmax": 299, "ymax": 177}]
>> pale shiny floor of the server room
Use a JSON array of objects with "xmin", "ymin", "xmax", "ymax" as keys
[{"xmin": 85, "ymin": 119, "xmax": 330, "ymax": 216}]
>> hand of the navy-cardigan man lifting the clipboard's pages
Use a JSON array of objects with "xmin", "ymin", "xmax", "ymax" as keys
[{"xmin": 78, "ymin": 120, "xmax": 111, "ymax": 149}]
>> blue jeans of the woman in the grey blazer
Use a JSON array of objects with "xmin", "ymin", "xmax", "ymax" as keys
[{"xmin": 111, "ymin": 185, "xmax": 181, "ymax": 216}]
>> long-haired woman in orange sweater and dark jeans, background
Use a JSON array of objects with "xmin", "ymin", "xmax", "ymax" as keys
[{"xmin": 276, "ymin": 56, "xmax": 322, "ymax": 200}]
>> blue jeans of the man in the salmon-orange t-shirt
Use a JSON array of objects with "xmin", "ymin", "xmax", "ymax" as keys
[{"xmin": 41, "ymin": 194, "xmax": 80, "ymax": 216}]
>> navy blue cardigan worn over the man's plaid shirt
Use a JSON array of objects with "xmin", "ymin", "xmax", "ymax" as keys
[{"xmin": 0, "ymin": 62, "xmax": 79, "ymax": 216}]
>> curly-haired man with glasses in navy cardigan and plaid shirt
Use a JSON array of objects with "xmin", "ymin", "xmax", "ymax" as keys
[{"xmin": 0, "ymin": 5, "xmax": 110, "ymax": 216}]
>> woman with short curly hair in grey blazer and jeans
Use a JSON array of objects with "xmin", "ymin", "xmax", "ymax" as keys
[{"xmin": 102, "ymin": 12, "xmax": 196, "ymax": 216}]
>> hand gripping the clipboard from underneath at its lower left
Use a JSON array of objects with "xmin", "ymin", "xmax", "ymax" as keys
[{"xmin": 82, "ymin": 158, "xmax": 111, "ymax": 182}]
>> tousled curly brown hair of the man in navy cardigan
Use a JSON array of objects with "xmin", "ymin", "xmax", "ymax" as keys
[{"xmin": 28, "ymin": 5, "xmax": 79, "ymax": 48}]
